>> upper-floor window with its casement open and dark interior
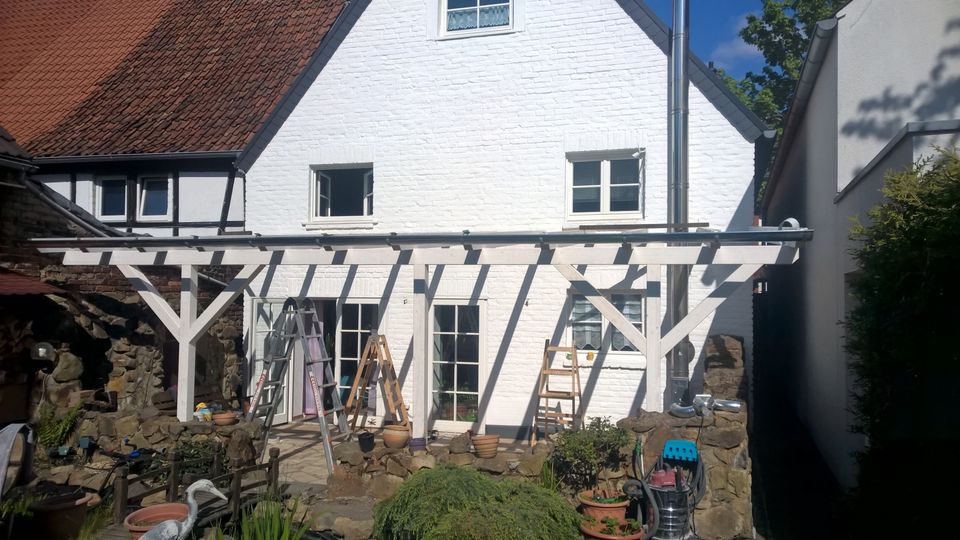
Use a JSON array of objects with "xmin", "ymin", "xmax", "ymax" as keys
[{"xmin": 310, "ymin": 167, "xmax": 373, "ymax": 221}]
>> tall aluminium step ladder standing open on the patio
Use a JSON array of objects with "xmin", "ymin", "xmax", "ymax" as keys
[{"xmin": 246, "ymin": 298, "xmax": 350, "ymax": 474}]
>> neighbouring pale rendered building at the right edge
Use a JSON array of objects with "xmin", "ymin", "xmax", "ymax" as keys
[{"xmin": 758, "ymin": 0, "xmax": 960, "ymax": 486}]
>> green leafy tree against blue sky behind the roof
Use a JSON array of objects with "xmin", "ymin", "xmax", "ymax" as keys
[{"xmin": 717, "ymin": 0, "xmax": 849, "ymax": 133}]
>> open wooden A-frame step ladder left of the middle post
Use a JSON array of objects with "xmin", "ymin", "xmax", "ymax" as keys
[{"xmin": 345, "ymin": 333, "xmax": 410, "ymax": 431}]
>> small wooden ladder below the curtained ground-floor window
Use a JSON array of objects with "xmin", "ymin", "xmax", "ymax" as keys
[{"xmin": 530, "ymin": 339, "xmax": 582, "ymax": 444}]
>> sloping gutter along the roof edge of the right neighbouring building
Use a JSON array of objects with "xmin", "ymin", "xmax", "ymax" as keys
[{"xmin": 760, "ymin": 17, "xmax": 838, "ymax": 215}]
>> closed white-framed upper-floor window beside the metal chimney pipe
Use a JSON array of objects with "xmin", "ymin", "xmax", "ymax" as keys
[{"xmin": 567, "ymin": 150, "xmax": 643, "ymax": 221}]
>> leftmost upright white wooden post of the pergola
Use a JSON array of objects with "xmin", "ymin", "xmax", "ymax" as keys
[{"xmin": 177, "ymin": 264, "xmax": 197, "ymax": 422}]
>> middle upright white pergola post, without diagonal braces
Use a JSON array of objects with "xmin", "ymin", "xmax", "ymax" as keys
[{"xmin": 411, "ymin": 264, "xmax": 431, "ymax": 437}]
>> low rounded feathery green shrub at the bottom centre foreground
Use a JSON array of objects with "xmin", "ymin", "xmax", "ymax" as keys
[{"xmin": 374, "ymin": 465, "xmax": 580, "ymax": 540}]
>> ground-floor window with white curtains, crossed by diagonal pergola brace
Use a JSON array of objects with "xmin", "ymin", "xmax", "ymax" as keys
[{"xmin": 570, "ymin": 292, "xmax": 643, "ymax": 352}]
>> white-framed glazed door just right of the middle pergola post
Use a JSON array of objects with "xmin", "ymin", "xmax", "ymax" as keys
[{"xmin": 430, "ymin": 299, "xmax": 485, "ymax": 431}]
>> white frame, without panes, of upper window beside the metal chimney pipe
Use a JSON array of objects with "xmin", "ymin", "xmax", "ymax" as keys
[{"xmin": 564, "ymin": 152, "xmax": 646, "ymax": 225}]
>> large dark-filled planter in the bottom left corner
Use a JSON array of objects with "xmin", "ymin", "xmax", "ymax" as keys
[{"xmin": 12, "ymin": 492, "xmax": 93, "ymax": 540}]
